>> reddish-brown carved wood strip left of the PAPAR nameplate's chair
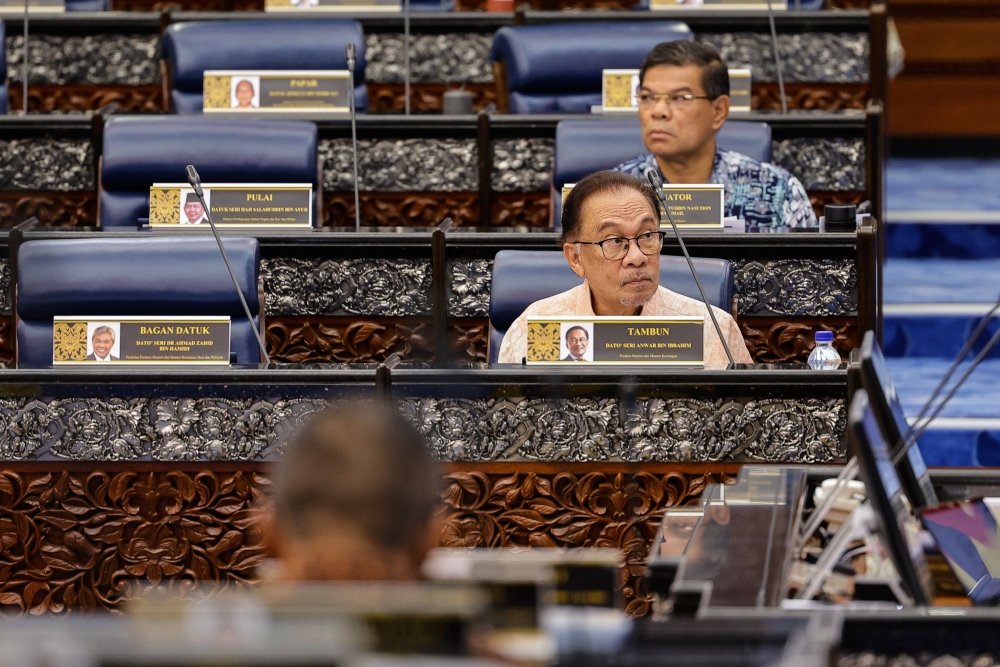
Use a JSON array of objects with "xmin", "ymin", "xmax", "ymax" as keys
[{"xmin": 8, "ymin": 84, "xmax": 163, "ymax": 112}]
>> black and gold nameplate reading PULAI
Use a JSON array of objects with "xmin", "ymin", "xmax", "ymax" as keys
[{"xmin": 149, "ymin": 183, "xmax": 313, "ymax": 229}]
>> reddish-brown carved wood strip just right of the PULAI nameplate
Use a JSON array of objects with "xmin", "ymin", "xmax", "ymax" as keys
[{"xmin": 320, "ymin": 192, "xmax": 479, "ymax": 227}]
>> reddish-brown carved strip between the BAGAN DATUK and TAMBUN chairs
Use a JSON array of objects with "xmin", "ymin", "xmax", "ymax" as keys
[{"xmin": 264, "ymin": 316, "xmax": 489, "ymax": 364}]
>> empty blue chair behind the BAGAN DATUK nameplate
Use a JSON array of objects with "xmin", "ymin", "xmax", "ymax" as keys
[{"xmin": 16, "ymin": 236, "xmax": 260, "ymax": 368}]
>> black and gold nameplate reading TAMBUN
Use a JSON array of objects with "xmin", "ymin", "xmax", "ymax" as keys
[{"xmin": 528, "ymin": 316, "xmax": 705, "ymax": 366}]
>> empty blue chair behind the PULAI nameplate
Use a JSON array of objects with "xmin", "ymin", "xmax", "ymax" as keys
[{"xmin": 98, "ymin": 116, "xmax": 322, "ymax": 227}]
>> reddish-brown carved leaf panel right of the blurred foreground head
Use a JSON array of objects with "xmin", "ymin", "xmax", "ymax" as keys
[{"xmin": 441, "ymin": 471, "xmax": 735, "ymax": 615}]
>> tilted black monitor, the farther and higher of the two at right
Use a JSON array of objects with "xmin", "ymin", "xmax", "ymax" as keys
[{"xmin": 861, "ymin": 331, "xmax": 939, "ymax": 509}]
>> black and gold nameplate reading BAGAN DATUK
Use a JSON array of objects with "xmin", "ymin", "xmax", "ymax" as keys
[{"xmin": 52, "ymin": 317, "xmax": 229, "ymax": 365}]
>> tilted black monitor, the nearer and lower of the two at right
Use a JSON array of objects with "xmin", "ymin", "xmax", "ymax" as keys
[{"xmin": 847, "ymin": 389, "xmax": 933, "ymax": 606}]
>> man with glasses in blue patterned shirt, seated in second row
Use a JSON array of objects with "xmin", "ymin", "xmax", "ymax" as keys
[{"xmin": 615, "ymin": 41, "xmax": 817, "ymax": 232}]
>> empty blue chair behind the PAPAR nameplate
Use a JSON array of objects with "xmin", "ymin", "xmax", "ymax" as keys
[{"xmin": 163, "ymin": 19, "xmax": 368, "ymax": 114}]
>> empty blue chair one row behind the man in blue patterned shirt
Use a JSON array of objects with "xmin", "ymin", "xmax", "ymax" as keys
[{"xmin": 490, "ymin": 21, "xmax": 694, "ymax": 113}]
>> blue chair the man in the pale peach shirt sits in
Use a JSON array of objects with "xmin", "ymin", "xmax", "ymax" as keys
[{"xmin": 489, "ymin": 250, "xmax": 734, "ymax": 364}]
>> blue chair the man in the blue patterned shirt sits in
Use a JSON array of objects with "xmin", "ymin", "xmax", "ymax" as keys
[{"xmin": 552, "ymin": 118, "xmax": 771, "ymax": 229}]
